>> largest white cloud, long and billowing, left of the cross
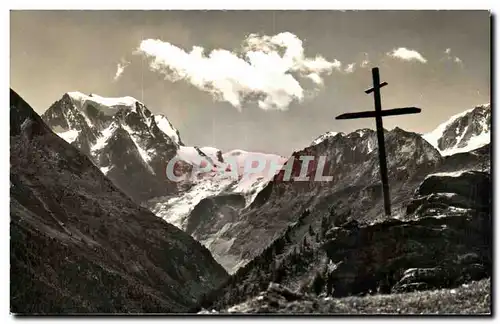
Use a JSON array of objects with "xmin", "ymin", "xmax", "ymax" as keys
[{"xmin": 133, "ymin": 32, "xmax": 349, "ymax": 110}]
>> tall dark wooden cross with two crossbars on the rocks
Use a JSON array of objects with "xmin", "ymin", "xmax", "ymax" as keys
[{"xmin": 335, "ymin": 67, "xmax": 421, "ymax": 216}]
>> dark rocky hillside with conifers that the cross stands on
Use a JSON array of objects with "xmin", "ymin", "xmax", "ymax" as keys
[{"xmin": 200, "ymin": 171, "xmax": 492, "ymax": 310}]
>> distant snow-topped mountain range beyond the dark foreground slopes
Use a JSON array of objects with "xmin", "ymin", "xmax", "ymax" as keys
[{"xmin": 42, "ymin": 92, "xmax": 491, "ymax": 273}]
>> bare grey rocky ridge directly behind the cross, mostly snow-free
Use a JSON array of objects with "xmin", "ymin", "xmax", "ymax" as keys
[{"xmin": 200, "ymin": 128, "xmax": 442, "ymax": 272}]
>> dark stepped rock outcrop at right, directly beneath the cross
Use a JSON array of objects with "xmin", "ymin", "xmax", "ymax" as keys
[{"xmin": 324, "ymin": 172, "xmax": 492, "ymax": 296}]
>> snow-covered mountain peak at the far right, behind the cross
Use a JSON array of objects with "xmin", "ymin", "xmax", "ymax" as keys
[{"xmin": 423, "ymin": 103, "xmax": 491, "ymax": 156}]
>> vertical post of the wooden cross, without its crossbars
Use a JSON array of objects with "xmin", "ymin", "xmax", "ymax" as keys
[{"xmin": 372, "ymin": 67, "xmax": 391, "ymax": 216}]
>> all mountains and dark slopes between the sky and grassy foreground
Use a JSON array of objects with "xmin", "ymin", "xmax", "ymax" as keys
[{"xmin": 11, "ymin": 91, "xmax": 491, "ymax": 312}]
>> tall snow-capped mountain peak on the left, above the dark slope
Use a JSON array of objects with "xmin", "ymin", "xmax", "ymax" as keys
[{"xmin": 42, "ymin": 92, "xmax": 188, "ymax": 202}]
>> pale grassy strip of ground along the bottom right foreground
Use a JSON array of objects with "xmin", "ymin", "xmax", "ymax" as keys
[{"xmin": 205, "ymin": 279, "xmax": 492, "ymax": 315}]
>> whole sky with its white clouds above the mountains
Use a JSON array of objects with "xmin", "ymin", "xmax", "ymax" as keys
[{"xmin": 10, "ymin": 10, "xmax": 491, "ymax": 156}]
